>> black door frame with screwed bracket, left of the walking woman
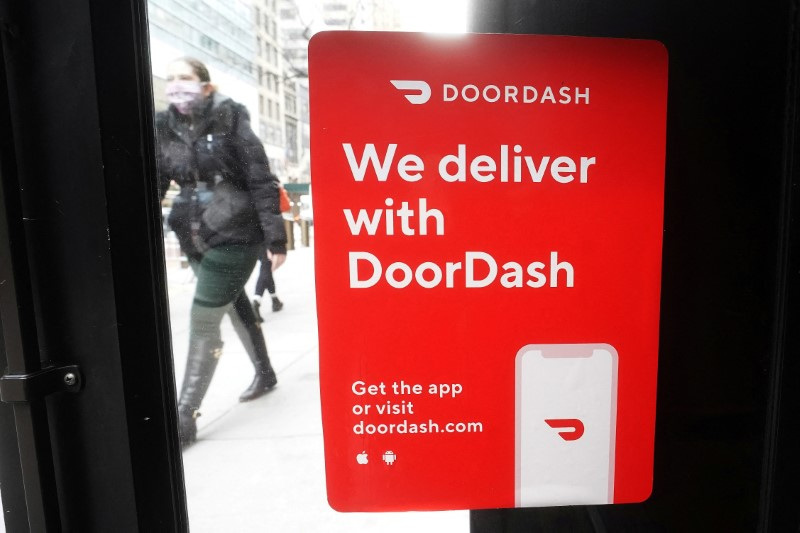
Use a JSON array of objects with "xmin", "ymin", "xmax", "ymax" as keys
[{"xmin": 0, "ymin": 0, "xmax": 188, "ymax": 532}]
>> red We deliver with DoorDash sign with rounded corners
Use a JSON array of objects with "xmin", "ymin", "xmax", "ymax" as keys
[{"xmin": 309, "ymin": 32, "xmax": 667, "ymax": 511}]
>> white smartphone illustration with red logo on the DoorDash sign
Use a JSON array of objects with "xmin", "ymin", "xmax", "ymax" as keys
[{"xmin": 516, "ymin": 344, "xmax": 618, "ymax": 507}]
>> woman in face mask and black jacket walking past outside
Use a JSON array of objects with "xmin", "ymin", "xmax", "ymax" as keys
[{"xmin": 156, "ymin": 58, "xmax": 286, "ymax": 447}]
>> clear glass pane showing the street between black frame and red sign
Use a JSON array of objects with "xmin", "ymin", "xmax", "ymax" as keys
[{"xmin": 149, "ymin": 0, "xmax": 468, "ymax": 532}]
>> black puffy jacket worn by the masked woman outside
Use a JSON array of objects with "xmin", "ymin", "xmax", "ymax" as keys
[{"xmin": 156, "ymin": 92, "xmax": 286, "ymax": 257}]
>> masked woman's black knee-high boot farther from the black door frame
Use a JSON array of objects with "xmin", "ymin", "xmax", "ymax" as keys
[{"xmin": 233, "ymin": 293, "xmax": 278, "ymax": 402}]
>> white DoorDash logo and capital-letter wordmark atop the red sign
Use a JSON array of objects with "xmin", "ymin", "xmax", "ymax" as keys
[{"xmin": 390, "ymin": 80, "xmax": 589, "ymax": 105}]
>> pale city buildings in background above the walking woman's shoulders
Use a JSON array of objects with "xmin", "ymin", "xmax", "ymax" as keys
[{"xmin": 149, "ymin": 0, "xmax": 402, "ymax": 183}]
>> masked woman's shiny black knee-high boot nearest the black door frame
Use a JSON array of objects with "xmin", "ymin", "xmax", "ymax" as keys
[{"xmin": 178, "ymin": 339, "xmax": 222, "ymax": 448}]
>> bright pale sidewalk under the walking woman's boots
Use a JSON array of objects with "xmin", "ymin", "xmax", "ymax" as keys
[{"xmin": 168, "ymin": 234, "xmax": 469, "ymax": 533}]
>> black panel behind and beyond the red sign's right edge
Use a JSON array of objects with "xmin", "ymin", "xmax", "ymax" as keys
[{"xmin": 470, "ymin": 0, "xmax": 800, "ymax": 533}]
